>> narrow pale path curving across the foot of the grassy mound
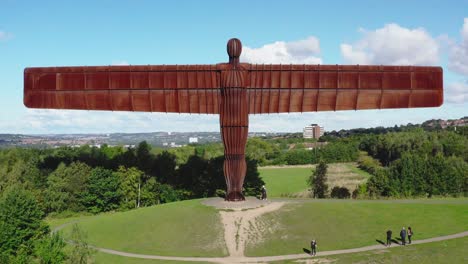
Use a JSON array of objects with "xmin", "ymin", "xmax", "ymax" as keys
[{"xmin": 53, "ymin": 222, "xmax": 468, "ymax": 263}]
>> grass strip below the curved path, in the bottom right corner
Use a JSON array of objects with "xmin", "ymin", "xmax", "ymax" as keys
[{"xmin": 274, "ymin": 237, "xmax": 468, "ymax": 264}]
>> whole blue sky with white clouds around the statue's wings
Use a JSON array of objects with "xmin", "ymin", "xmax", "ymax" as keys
[{"xmin": 0, "ymin": 0, "xmax": 468, "ymax": 134}]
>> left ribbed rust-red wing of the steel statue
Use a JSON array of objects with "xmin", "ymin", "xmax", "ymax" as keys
[{"xmin": 24, "ymin": 65, "xmax": 220, "ymax": 114}]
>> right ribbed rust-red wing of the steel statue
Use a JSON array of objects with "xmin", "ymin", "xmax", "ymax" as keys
[{"xmin": 248, "ymin": 65, "xmax": 443, "ymax": 114}]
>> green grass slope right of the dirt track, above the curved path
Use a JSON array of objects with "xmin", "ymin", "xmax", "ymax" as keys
[{"xmin": 246, "ymin": 199, "xmax": 468, "ymax": 256}]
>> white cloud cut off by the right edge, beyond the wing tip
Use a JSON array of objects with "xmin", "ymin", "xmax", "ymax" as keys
[{"xmin": 449, "ymin": 18, "xmax": 468, "ymax": 75}]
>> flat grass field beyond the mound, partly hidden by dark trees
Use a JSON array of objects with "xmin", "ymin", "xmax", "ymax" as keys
[{"xmin": 258, "ymin": 163, "xmax": 370, "ymax": 197}]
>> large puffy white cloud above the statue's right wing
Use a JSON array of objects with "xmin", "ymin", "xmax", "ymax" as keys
[{"xmin": 340, "ymin": 23, "xmax": 439, "ymax": 65}]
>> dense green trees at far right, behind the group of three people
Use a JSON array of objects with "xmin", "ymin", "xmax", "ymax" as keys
[{"xmin": 359, "ymin": 129, "xmax": 468, "ymax": 197}]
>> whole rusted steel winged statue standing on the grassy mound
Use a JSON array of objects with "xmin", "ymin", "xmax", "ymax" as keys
[{"xmin": 24, "ymin": 39, "xmax": 443, "ymax": 201}]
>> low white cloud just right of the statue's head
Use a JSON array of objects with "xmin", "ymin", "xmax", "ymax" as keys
[{"xmin": 240, "ymin": 36, "xmax": 322, "ymax": 64}]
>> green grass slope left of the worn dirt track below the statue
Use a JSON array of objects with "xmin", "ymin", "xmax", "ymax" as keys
[{"xmin": 54, "ymin": 200, "xmax": 227, "ymax": 257}]
